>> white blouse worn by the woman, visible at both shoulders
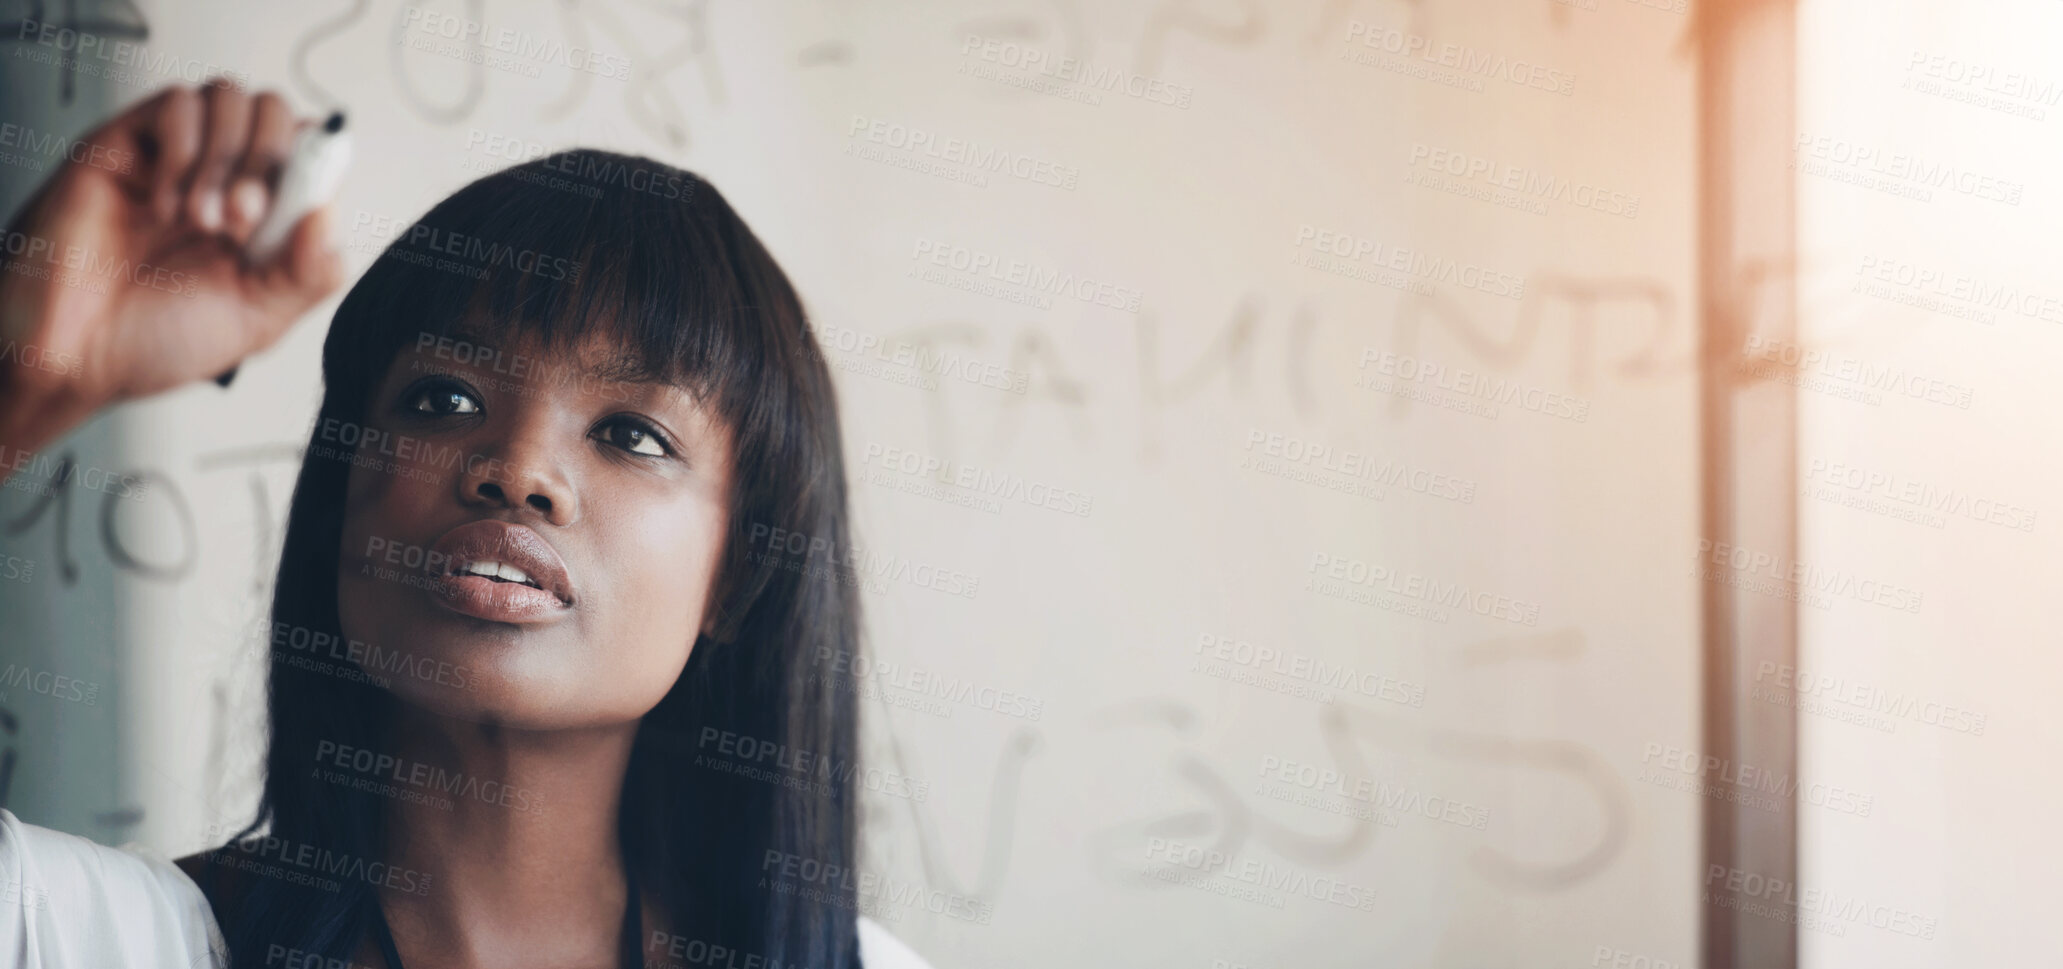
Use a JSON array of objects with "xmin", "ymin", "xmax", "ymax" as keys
[{"xmin": 0, "ymin": 808, "xmax": 930, "ymax": 969}]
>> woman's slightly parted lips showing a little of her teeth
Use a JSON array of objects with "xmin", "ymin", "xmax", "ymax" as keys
[{"xmin": 431, "ymin": 520, "xmax": 574, "ymax": 623}]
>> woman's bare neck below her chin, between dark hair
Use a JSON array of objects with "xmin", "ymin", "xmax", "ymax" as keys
[{"xmin": 361, "ymin": 705, "xmax": 637, "ymax": 969}]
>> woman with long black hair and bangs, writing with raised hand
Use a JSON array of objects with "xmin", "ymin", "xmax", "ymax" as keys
[{"xmin": 0, "ymin": 85, "xmax": 922, "ymax": 969}]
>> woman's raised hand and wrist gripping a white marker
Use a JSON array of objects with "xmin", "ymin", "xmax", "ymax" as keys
[{"xmin": 0, "ymin": 82, "xmax": 345, "ymax": 449}]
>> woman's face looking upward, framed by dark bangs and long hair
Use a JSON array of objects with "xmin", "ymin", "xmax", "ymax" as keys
[{"xmin": 332, "ymin": 325, "xmax": 730, "ymax": 730}]
